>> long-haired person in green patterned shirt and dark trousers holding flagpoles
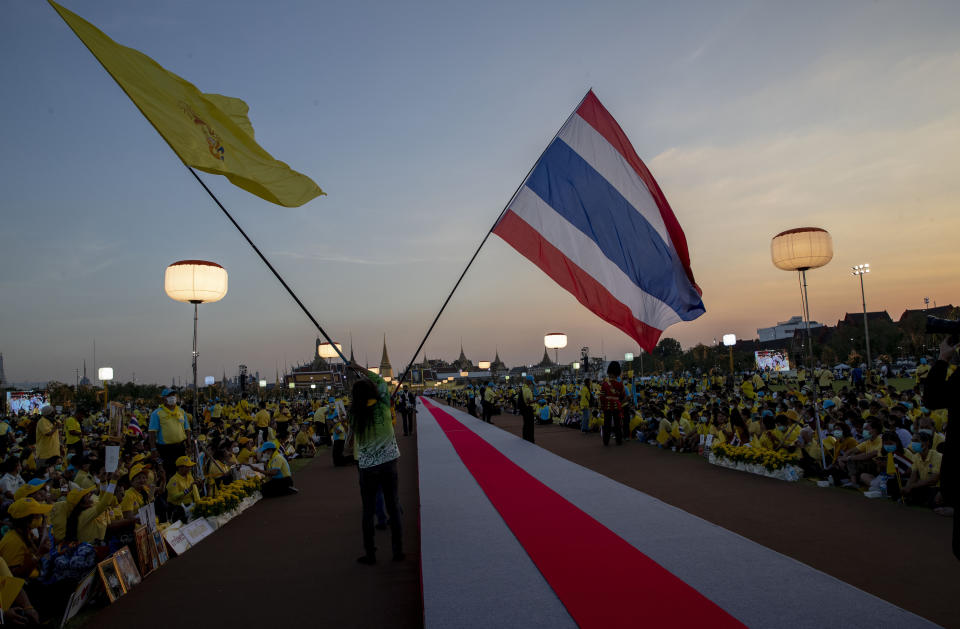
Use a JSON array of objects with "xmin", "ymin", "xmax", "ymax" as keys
[{"xmin": 348, "ymin": 371, "xmax": 405, "ymax": 565}]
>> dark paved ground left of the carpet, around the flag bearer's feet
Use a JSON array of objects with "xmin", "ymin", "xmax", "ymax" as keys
[{"xmin": 86, "ymin": 436, "xmax": 423, "ymax": 629}]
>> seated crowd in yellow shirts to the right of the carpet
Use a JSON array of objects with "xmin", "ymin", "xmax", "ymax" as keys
[{"xmin": 442, "ymin": 361, "xmax": 953, "ymax": 515}]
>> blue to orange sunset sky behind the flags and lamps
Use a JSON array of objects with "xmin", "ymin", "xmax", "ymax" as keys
[{"xmin": 0, "ymin": 0, "xmax": 960, "ymax": 383}]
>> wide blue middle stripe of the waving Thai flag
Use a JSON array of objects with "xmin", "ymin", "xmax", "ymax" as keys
[{"xmin": 526, "ymin": 138, "xmax": 705, "ymax": 321}]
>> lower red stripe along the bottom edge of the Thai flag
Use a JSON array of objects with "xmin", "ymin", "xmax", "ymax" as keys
[{"xmin": 493, "ymin": 210, "xmax": 663, "ymax": 352}]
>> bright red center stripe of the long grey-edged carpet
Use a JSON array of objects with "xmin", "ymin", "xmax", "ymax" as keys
[{"xmin": 424, "ymin": 400, "xmax": 744, "ymax": 629}]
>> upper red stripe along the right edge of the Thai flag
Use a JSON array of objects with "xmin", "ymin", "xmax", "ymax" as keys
[{"xmin": 577, "ymin": 90, "xmax": 703, "ymax": 295}]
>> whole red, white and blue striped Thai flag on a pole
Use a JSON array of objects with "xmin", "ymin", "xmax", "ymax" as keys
[{"xmin": 493, "ymin": 90, "xmax": 706, "ymax": 352}]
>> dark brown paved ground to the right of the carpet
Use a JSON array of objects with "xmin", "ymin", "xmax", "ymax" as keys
[{"xmin": 440, "ymin": 402, "xmax": 960, "ymax": 627}]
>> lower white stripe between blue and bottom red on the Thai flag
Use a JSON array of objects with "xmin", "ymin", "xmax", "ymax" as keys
[{"xmin": 510, "ymin": 186, "xmax": 681, "ymax": 330}]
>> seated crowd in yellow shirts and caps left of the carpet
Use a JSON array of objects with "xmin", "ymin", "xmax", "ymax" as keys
[{"xmin": 0, "ymin": 389, "xmax": 346, "ymax": 624}]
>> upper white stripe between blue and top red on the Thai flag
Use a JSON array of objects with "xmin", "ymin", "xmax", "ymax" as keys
[{"xmin": 558, "ymin": 114, "xmax": 676, "ymax": 255}]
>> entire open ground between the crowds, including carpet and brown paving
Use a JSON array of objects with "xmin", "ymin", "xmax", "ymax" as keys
[{"xmin": 88, "ymin": 402, "xmax": 960, "ymax": 629}]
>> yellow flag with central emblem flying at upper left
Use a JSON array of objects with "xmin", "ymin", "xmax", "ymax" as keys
[{"xmin": 49, "ymin": 0, "xmax": 325, "ymax": 207}]
